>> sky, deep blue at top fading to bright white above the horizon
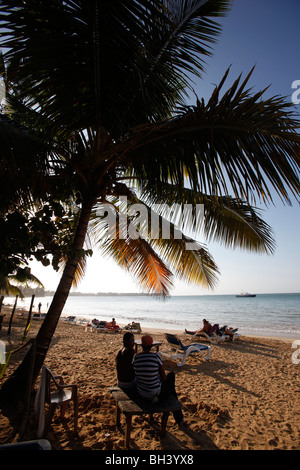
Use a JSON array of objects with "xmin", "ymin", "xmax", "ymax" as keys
[{"xmin": 31, "ymin": 0, "xmax": 300, "ymax": 295}]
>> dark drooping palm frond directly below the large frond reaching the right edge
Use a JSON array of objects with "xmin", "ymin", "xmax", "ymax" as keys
[{"xmin": 141, "ymin": 183, "xmax": 275, "ymax": 254}]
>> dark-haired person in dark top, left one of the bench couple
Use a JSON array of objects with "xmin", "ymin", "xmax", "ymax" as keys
[{"xmin": 116, "ymin": 332, "xmax": 135, "ymax": 389}]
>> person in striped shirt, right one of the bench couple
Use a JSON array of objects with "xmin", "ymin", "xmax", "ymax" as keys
[{"xmin": 133, "ymin": 335, "xmax": 184, "ymax": 425}]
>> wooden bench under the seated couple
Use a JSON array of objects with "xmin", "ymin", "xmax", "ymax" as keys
[{"xmin": 109, "ymin": 387, "xmax": 182, "ymax": 448}]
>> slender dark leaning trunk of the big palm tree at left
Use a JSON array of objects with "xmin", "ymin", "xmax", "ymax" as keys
[{"xmin": 33, "ymin": 199, "xmax": 94, "ymax": 381}]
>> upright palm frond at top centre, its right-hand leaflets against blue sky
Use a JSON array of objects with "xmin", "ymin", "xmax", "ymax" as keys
[{"xmin": 125, "ymin": 0, "xmax": 231, "ymax": 122}]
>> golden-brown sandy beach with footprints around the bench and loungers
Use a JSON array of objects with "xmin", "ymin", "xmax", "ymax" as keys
[{"xmin": 0, "ymin": 312, "xmax": 300, "ymax": 451}]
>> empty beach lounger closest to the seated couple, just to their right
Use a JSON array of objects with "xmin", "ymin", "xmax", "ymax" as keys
[{"xmin": 160, "ymin": 333, "xmax": 211, "ymax": 367}]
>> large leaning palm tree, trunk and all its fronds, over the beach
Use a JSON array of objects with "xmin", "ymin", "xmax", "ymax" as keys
[{"xmin": 0, "ymin": 0, "xmax": 300, "ymax": 388}]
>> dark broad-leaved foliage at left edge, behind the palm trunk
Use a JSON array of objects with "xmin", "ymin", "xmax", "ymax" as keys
[{"xmin": 0, "ymin": 201, "xmax": 78, "ymax": 297}]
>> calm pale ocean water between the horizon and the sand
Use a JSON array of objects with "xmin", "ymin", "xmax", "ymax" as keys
[{"xmin": 15, "ymin": 293, "xmax": 300, "ymax": 339}]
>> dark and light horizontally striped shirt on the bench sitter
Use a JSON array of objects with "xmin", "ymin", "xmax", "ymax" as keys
[{"xmin": 133, "ymin": 352, "xmax": 163, "ymax": 399}]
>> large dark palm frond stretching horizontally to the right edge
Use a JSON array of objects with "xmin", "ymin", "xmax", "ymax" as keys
[{"xmin": 117, "ymin": 66, "xmax": 300, "ymax": 203}]
